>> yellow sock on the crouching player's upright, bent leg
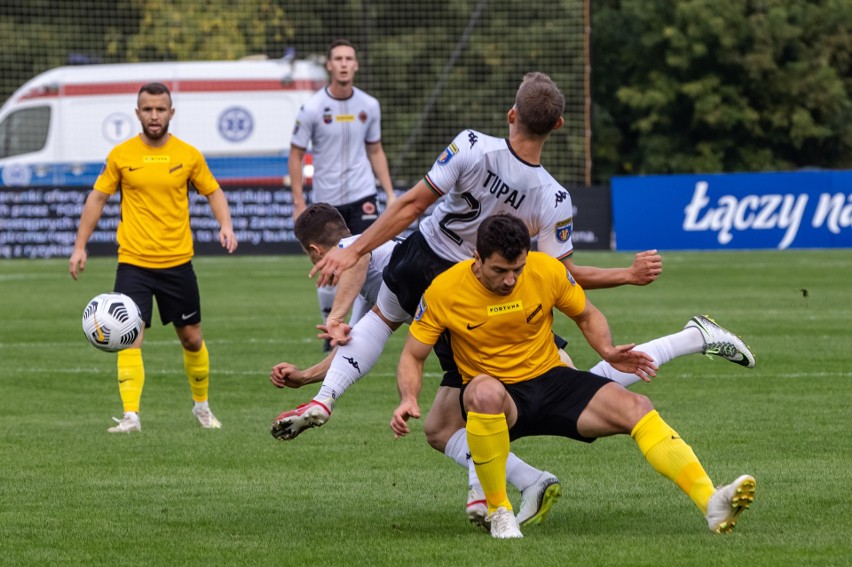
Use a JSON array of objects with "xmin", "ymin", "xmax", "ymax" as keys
[{"xmin": 467, "ymin": 411, "xmax": 512, "ymax": 514}]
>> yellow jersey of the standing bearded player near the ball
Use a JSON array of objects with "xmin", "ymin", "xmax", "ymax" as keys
[{"xmin": 94, "ymin": 136, "xmax": 219, "ymax": 268}]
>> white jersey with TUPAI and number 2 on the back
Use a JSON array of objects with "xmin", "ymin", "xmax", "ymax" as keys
[{"xmin": 420, "ymin": 130, "xmax": 574, "ymax": 262}]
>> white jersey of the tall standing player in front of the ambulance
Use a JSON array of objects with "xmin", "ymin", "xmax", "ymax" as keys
[{"xmin": 290, "ymin": 88, "xmax": 382, "ymax": 206}]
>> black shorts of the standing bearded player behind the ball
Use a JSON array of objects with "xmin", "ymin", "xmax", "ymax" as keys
[{"xmin": 114, "ymin": 262, "xmax": 201, "ymax": 328}]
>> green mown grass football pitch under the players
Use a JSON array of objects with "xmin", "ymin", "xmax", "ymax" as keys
[{"xmin": 0, "ymin": 250, "xmax": 852, "ymax": 567}]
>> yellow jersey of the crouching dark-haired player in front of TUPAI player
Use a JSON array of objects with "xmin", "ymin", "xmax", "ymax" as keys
[{"xmin": 411, "ymin": 252, "xmax": 586, "ymax": 384}]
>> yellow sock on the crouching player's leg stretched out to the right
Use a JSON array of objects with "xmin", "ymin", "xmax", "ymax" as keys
[{"xmin": 630, "ymin": 410, "xmax": 713, "ymax": 514}]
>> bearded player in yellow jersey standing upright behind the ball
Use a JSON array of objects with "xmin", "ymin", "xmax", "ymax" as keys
[{"xmin": 70, "ymin": 83, "xmax": 237, "ymax": 433}]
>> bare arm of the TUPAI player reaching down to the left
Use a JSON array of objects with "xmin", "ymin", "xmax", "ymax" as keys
[{"xmin": 310, "ymin": 179, "xmax": 438, "ymax": 286}]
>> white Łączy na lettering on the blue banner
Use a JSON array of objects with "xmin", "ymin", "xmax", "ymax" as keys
[{"xmin": 683, "ymin": 181, "xmax": 852, "ymax": 250}]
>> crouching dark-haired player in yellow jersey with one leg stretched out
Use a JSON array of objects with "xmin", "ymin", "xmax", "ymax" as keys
[{"xmin": 391, "ymin": 214, "xmax": 755, "ymax": 538}]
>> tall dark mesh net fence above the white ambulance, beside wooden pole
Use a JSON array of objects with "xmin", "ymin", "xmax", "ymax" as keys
[{"xmin": 0, "ymin": 0, "xmax": 591, "ymax": 188}]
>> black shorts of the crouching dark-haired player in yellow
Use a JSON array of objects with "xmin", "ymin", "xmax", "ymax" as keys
[{"xmin": 459, "ymin": 366, "xmax": 612, "ymax": 443}]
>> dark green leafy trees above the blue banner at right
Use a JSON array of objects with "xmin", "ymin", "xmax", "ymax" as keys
[{"xmin": 592, "ymin": 0, "xmax": 852, "ymax": 178}]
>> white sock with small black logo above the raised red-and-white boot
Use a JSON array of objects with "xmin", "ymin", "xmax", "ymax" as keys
[{"xmin": 314, "ymin": 311, "xmax": 393, "ymax": 409}]
